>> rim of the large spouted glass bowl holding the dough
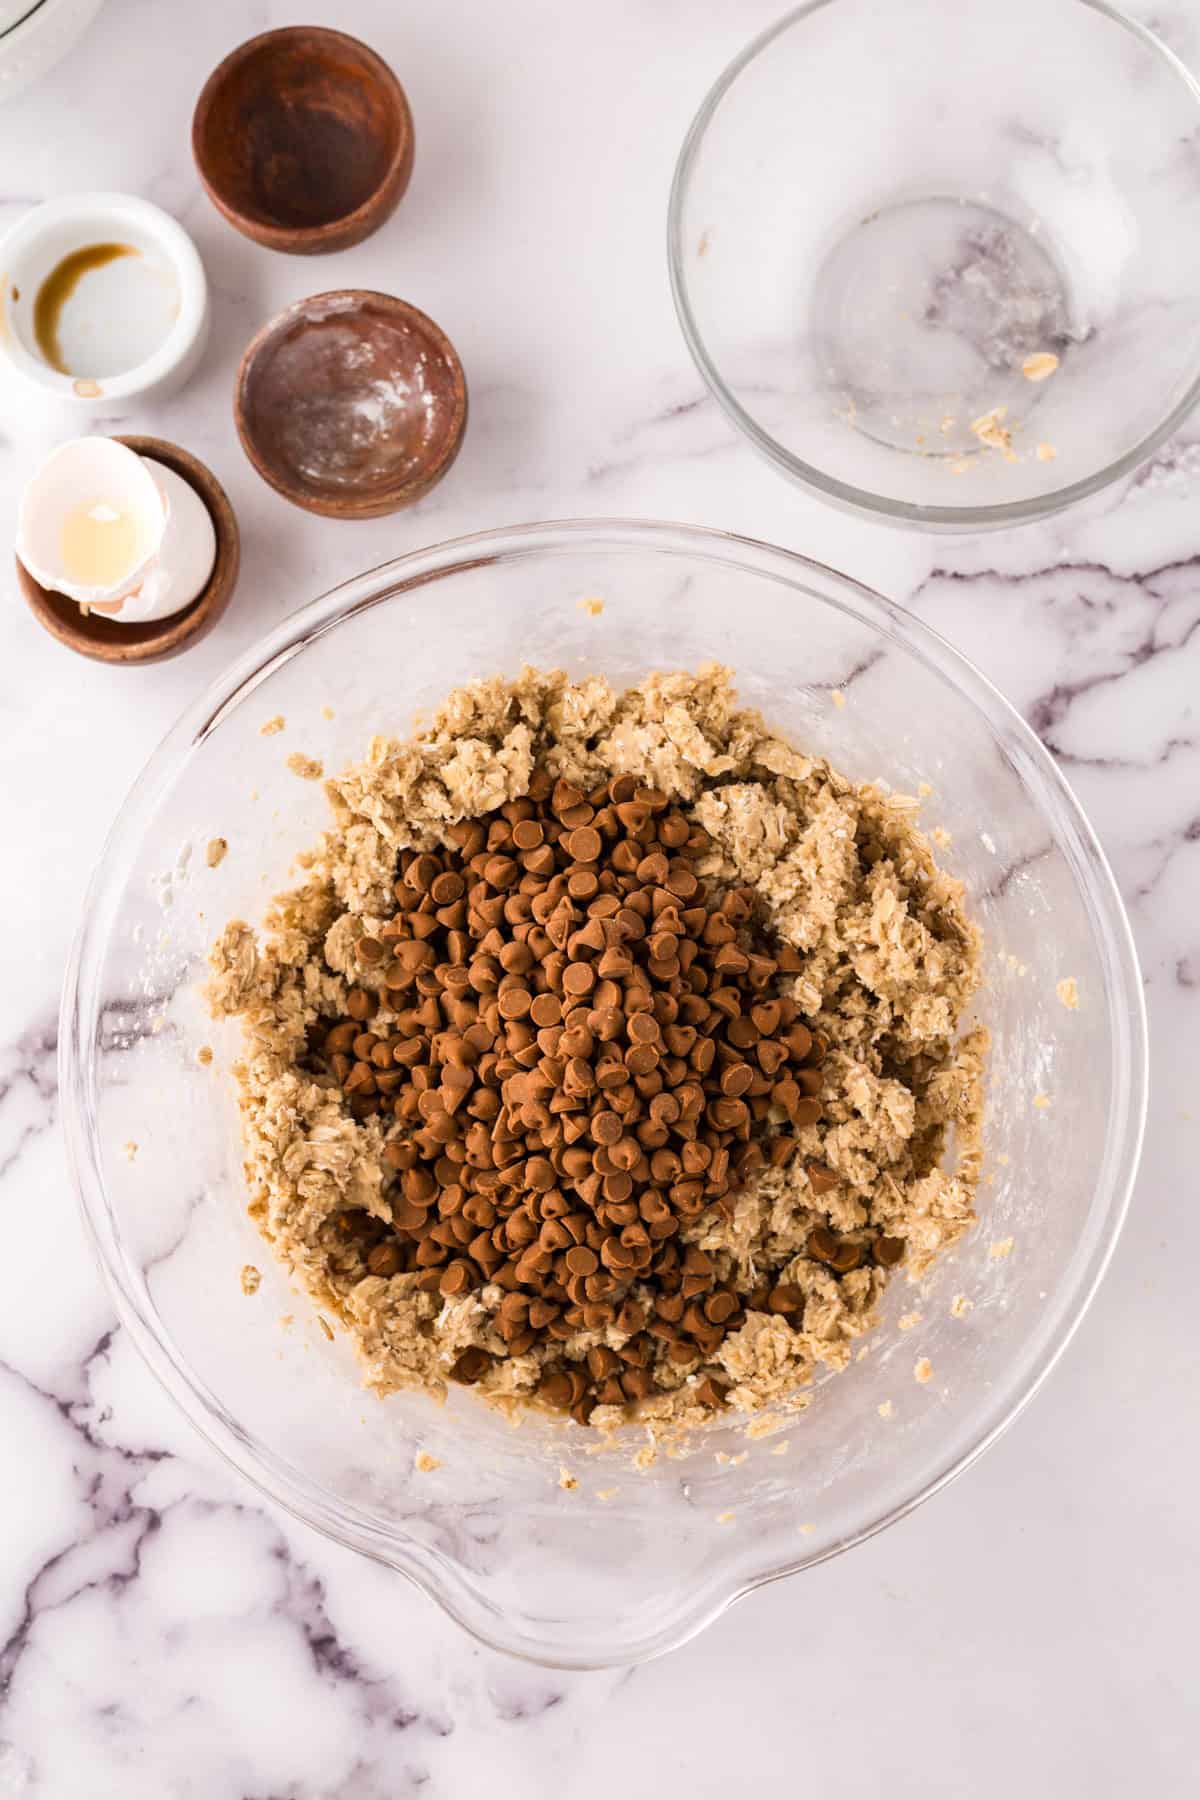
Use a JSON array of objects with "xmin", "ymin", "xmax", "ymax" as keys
[{"xmin": 59, "ymin": 518, "xmax": 1148, "ymax": 1669}]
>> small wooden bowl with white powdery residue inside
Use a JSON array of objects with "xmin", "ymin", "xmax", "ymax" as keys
[{"xmin": 234, "ymin": 288, "xmax": 466, "ymax": 518}]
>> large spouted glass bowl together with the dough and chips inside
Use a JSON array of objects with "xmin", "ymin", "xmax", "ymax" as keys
[{"xmin": 61, "ymin": 522, "xmax": 1144, "ymax": 1667}]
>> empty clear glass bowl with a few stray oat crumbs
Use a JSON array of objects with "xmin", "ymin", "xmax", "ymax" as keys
[{"xmin": 669, "ymin": 0, "xmax": 1200, "ymax": 529}]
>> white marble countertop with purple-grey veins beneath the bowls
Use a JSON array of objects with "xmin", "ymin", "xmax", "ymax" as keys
[{"xmin": 0, "ymin": 0, "xmax": 1200, "ymax": 1800}]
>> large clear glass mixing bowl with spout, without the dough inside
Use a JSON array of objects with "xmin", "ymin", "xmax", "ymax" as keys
[{"xmin": 61, "ymin": 520, "xmax": 1146, "ymax": 1667}]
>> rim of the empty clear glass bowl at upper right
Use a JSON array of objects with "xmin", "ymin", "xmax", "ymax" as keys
[{"xmin": 667, "ymin": 0, "xmax": 1200, "ymax": 531}]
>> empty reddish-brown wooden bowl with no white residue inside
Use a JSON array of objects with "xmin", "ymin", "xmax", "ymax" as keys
[{"xmin": 193, "ymin": 25, "xmax": 412, "ymax": 256}]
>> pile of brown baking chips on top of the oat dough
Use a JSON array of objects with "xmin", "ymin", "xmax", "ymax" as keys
[{"xmin": 311, "ymin": 770, "xmax": 903, "ymax": 1422}]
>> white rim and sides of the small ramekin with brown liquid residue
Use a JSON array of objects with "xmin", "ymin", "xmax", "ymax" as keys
[{"xmin": 0, "ymin": 193, "xmax": 209, "ymax": 414}]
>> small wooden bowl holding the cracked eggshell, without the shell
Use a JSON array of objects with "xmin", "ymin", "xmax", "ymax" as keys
[{"xmin": 16, "ymin": 437, "xmax": 241, "ymax": 664}]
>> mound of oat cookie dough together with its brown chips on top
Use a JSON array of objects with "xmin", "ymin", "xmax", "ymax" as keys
[{"xmin": 209, "ymin": 666, "xmax": 986, "ymax": 1429}]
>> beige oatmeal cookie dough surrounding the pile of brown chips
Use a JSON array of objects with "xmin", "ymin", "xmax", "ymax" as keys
[{"xmin": 209, "ymin": 666, "xmax": 986, "ymax": 1427}]
